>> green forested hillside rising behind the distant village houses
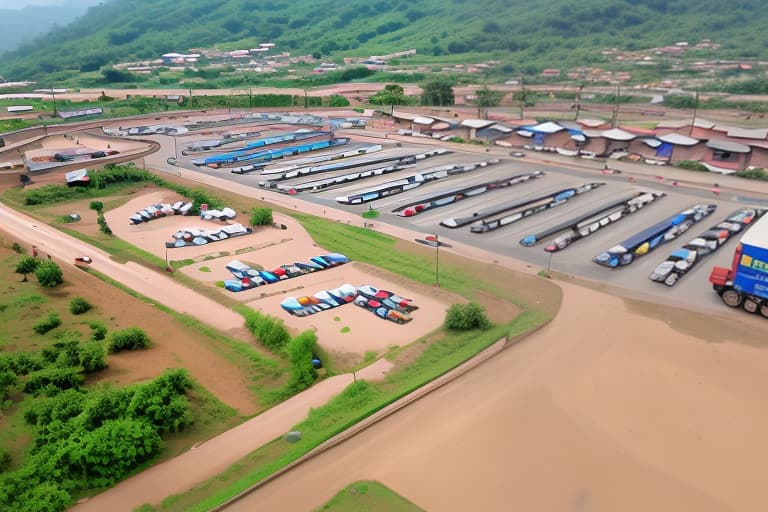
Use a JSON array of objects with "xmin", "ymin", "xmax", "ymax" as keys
[{"xmin": 0, "ymin": 0, "xmax": 768, "ymax": 79}]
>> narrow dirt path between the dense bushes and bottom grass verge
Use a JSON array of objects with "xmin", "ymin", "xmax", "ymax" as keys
[{"xmin": 70, "ymin": 359, "xmax": 391, "ymax": 512}]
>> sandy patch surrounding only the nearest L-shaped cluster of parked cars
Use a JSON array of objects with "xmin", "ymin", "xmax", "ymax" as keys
[{"xmin": 247, "ymin": 262, "xmax": 450, "ymax": 353}]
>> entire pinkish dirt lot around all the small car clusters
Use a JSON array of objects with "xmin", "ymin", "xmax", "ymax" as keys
[{"xmin": 105, "ymin": 191, "xmax": 452, "ymax": 354}]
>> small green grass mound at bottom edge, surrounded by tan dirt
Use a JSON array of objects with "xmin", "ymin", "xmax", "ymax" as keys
[{"xmin": 317, "ymin": 480, "xmax": 424, "ymax": 512}]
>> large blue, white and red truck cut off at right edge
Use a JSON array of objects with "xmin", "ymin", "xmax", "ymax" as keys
[{"xmin": 709, "ymin": 211, "xmax": 768, "ymax": 318}]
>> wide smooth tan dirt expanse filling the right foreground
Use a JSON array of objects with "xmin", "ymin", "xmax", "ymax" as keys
[{"xmin": 230, "ymin": 284, "xmax": 768, "ymax": 512}]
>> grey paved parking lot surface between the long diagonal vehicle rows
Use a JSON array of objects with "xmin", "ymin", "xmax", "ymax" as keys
[{"xmin": 160, "ymin": 130, "xmax": 766, "ymax": 310}]
